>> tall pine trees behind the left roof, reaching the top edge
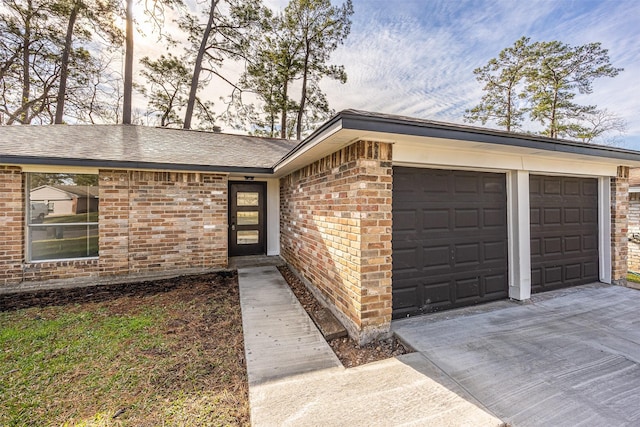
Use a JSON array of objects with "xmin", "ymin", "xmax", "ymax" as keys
[{"xmin": 0, "ymin": 0, "xmax": 353, "ymax": 138}]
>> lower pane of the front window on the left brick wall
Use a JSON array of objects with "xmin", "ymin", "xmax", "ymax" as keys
[{"xmin": 29, "ymin": 224, "xmax": 98, "ymax": 261}]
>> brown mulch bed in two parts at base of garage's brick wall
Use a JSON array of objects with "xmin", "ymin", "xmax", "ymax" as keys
[{"xmin": 278, "ymin": 266, "xmax": 410, "ymax": 368}]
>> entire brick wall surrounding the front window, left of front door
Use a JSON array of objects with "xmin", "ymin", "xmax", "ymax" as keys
[{"xmin": 0, "ymin": 167, "xmax": 227, "ymax": 292}]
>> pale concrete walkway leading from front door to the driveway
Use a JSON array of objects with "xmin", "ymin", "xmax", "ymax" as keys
[{"xmin": 238, "ymin": 267, "xmax": 502, "ymax": 427}]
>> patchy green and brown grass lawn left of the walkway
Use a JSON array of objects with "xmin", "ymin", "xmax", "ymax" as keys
[{"xmin": 0, "ymin": 275, "xmax": 249, "ymax": 426}]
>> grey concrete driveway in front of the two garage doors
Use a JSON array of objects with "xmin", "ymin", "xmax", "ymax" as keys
[{"xmin": 392, "ymin": 285, "xmax": 640, "ymax": 427}]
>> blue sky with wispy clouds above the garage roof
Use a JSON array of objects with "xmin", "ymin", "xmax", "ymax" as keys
[{"xmin": 135, "ymin": 0, "xmax": 640, "ymax": 150}]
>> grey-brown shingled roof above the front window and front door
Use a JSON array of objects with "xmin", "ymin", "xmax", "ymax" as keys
[{"xmin": 0, "ymin": 125, "xmax": 298, "ymax": 173}]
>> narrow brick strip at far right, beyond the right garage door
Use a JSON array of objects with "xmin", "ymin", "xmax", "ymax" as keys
[{"xmin": 611, "ymin": 166, "xmax": 629, "ymax": 285}]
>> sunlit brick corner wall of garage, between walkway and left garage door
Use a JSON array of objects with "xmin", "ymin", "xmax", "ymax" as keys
[{"xmin": 280, "ymin": 141, "xmax": 392, "ymax": 342}]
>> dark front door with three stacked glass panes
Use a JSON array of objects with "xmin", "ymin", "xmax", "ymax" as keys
[{"xmin": 229, "ymin": 182, "xmax": 267, "ymax": 256}]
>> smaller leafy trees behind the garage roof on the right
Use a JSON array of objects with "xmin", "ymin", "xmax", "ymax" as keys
[{"xmin": 465, "ymin": 37, "xmax": 626, "ymax": 142}]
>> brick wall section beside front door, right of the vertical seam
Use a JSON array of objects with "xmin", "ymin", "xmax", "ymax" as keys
[{"xmin": 128, "ymin": 171, "xmax": 227, "ymax": 273}]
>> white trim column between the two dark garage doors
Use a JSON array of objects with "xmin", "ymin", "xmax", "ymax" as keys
[{"xmin": 507, "ymin": 170, "xmax": 531, "ymax": 301}]
